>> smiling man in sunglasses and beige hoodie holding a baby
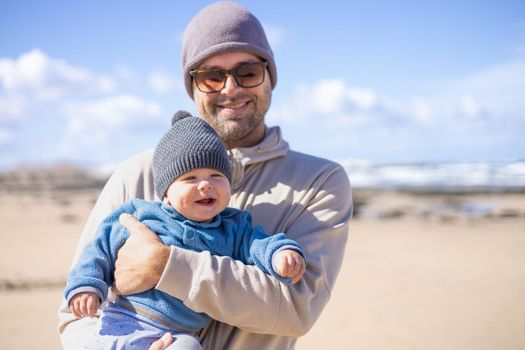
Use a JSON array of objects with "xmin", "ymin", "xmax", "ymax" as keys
[{"xmin": 59, "ymin": 2, "xmax": 352, "ymax": 349}]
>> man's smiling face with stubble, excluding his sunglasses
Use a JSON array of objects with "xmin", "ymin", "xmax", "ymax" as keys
[{"xmin": 193, "ymin": 52, "xmax": 272, "ymax": 149}]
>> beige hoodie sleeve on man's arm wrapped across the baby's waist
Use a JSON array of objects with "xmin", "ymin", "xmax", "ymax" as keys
[{"xmin": 156, "ymin": 165, "xmax": 352, "ymax": 337}]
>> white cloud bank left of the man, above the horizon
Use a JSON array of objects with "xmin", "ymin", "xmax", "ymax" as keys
[{"xmin": 0, "ymin": 49, "xmax": 192, "ymax": 167}]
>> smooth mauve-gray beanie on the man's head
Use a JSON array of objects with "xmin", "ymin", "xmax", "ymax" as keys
[{"xmin": 182, "ymin": 1, "xmax": 277, "ymax": 98}]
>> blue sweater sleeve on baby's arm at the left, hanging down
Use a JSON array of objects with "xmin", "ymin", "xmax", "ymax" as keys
[{"xmin": 64, "ymin": 201, "xmax": 136, "ymax": 304}]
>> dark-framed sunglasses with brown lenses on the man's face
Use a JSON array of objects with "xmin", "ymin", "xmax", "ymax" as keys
[{"xmin": 190, "ymin": 61, "xmax": 268, "ymax": 93}]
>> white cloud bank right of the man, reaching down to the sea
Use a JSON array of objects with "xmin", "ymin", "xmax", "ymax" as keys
[{"xmin": 270, "ymin": 56, "xmax": 525, "ymax": 161}]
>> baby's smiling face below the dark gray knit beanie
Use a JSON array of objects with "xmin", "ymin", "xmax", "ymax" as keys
[{"xmin": 163, "ymin": 168, "xmax": 231, "ymax": 222}]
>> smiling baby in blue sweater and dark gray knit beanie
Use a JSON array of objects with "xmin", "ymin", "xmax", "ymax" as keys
[{"xmin": 64, "ymin": 111, "xmax": 305, "ymax": 349}]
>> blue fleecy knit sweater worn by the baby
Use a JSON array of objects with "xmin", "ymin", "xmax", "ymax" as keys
[{"xmin": 64, "ymin": 199, "xmax": 304, "ymax": 333}]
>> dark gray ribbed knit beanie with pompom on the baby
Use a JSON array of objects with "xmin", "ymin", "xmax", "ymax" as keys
[{"xmin": 153, "ymin": 111, "xmax": 232, "ymax": 199}]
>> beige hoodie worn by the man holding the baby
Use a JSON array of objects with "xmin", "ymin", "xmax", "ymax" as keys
[{"xmin": 59, "ymin": 127, "xmax": 352, "ymax": 350}]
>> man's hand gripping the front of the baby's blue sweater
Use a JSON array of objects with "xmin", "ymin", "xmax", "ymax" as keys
[{"xmin": 115, "ymin": 214, "xmax": 170, "ymax": 295}]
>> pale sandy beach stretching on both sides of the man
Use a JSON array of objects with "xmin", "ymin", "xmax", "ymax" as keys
[{"xmin": 0, "ymin": 168, "xmax": 525, "ymax": 350}]
